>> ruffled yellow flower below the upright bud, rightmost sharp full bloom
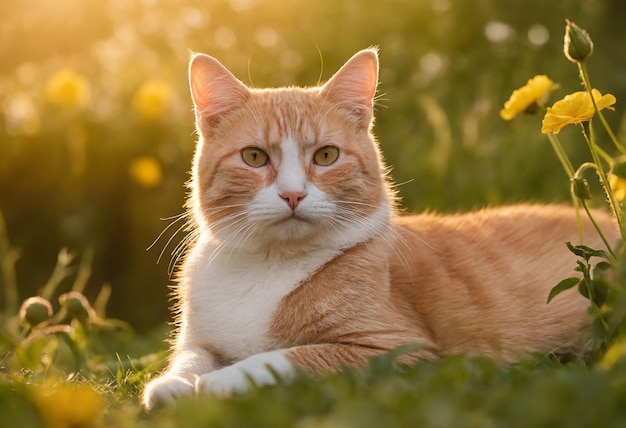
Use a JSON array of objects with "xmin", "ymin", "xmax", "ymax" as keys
[{"xmin": 541, "ymin": 89, "xmax": 616, "ymax": 134}]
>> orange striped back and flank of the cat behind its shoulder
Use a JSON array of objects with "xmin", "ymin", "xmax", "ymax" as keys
[{"xmin": 390, "ymin": 205, "xmax": 617, "ymax": 358}]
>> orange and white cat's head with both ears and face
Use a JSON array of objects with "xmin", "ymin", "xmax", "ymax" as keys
[{"xmin": 189, "ymin": 49, "xmax": 393, "ymax": 252}]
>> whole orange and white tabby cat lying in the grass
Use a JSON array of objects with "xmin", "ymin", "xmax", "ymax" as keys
[{"xmin": 143, "ymin": 49, "xmax": 616, "ymax": 409}]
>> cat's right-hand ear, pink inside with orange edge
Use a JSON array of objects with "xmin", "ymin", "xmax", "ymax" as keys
[{"xmin": 321, "ymin": 48, "xmax": 378, "ymax": 126}]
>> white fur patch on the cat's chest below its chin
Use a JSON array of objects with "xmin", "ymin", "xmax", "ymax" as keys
[{"xmin": 182, "ymin": 241, "xmax": 336, "ymax": 360}]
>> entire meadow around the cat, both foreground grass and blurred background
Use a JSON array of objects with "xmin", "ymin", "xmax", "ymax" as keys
[{"xmin": 0, "ymin": 0, "xmax": 626, "ymax": 428}]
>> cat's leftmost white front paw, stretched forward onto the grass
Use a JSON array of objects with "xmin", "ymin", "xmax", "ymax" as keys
[{"xmin": 142, "ymin": 348, "xmax": 217, "ymax": 410}]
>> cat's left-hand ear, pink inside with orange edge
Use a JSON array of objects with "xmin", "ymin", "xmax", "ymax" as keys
[{"xmin": 189, "ymin": 54, "xmax": 250, "ymax": 130}]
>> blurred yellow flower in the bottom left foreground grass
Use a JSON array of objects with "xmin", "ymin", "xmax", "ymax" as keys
[{"xmin": 36, "ymin": 383, "xmax": 102, "ymax": 428}]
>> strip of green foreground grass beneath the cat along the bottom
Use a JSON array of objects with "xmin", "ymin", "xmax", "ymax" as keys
[{"xmin": 0, "ymin": 340, "xmax": 626, "ymax": 427}]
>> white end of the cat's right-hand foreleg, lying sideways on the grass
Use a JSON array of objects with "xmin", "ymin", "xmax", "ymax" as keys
[{"xmin": 196, "ymin": 351, "xmax": 294, "ymax": 397}]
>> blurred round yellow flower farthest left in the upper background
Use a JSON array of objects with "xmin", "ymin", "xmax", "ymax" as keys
[{"xmin": 45, "ymin": 69, "xmax": 89, "ymax": 107}]
